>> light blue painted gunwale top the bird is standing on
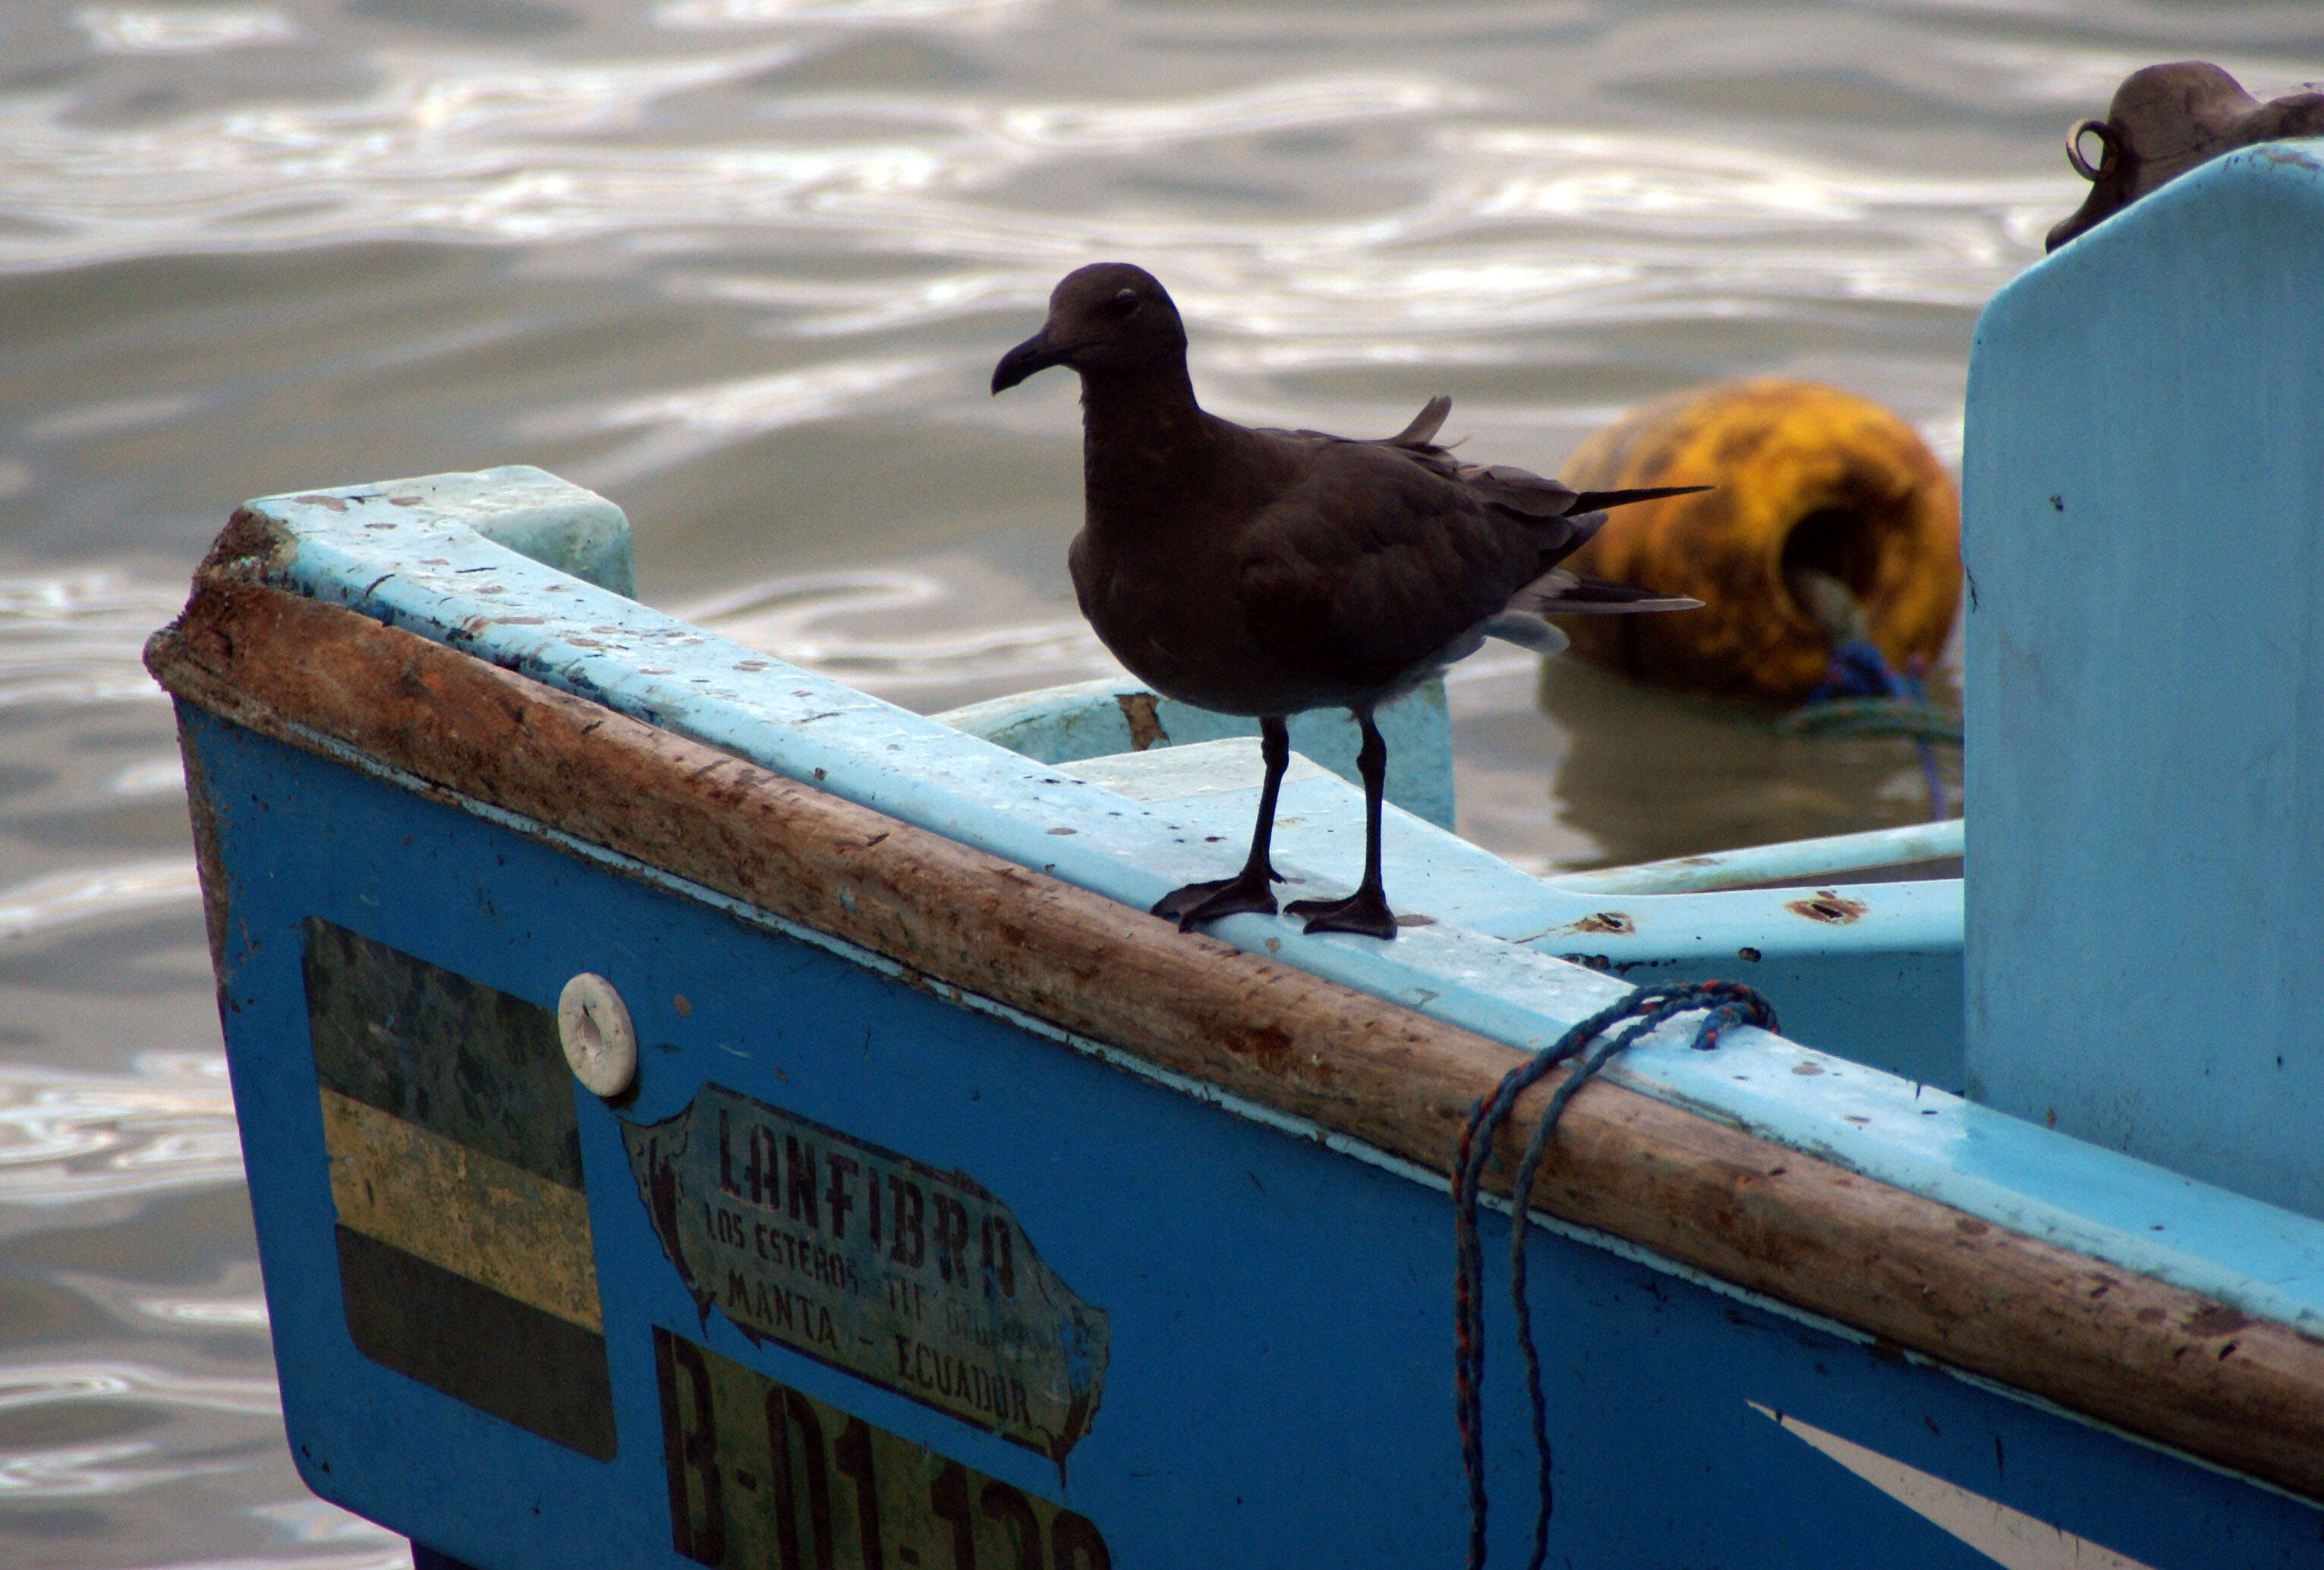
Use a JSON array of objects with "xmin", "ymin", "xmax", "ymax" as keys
[{"xmin": 226, "ymin": 470, "xmax": 2324, "ymax": 1333}]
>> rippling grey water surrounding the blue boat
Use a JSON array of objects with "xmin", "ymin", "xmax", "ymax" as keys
[{"xmin": 0, "ymin": 0, "xmax": 2324, "ymax": 1570}]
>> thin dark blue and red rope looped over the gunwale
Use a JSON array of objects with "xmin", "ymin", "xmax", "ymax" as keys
[{"xmin": 1453, "ymin": 982, "xmax": 1775, "ymax": 1570}]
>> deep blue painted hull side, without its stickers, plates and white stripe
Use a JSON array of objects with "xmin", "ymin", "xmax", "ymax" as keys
[{"xmin": 186, "ymin": 711, "xmax": 2324, "ymax": 1570}]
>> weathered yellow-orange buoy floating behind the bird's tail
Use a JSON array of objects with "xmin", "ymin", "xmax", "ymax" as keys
[{"xmin": 1560, "ymin": 381, "xmax": 1961, "ymax": 702}]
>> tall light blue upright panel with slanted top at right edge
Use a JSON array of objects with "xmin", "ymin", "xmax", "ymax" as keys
[{"xmin": 1961, "ymin": 142, "xmax": 2324, "ymax": 1214}]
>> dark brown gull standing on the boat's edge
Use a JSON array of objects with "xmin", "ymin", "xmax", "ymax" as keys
[{"xmin": 992, "ymin": 263, "xmax": 1701, "ymax": 938}]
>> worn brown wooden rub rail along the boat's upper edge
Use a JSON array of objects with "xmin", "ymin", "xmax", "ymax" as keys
[{"xmin": 146, "ymin": 544, "xmax": 2324, "ymax": 1498}]
